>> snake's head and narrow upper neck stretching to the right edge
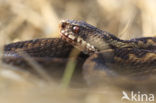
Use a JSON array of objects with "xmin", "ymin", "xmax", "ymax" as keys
[{"xmin": 60, "ymin": 20, "xmax": 156, "ymax": 53}]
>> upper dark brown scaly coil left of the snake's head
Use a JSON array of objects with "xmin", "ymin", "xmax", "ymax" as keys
[{"xmin": 4, "ymin": 38, "xmax": 73, "ymax": 58}]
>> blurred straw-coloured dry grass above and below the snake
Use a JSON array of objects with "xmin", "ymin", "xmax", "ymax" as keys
[{"xmin": 0, "ymin": 0, "xmax": 156, "ymax": 103}]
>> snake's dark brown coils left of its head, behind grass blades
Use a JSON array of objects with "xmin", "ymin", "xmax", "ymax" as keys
[{"xmin": 3, "ymin": 38, "xmax": 87, "ymax": 81}]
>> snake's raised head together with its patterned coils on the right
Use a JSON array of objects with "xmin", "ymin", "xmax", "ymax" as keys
[{"xmin": 60, "ymin": 20, "xmax": 156, "ymax": 80}]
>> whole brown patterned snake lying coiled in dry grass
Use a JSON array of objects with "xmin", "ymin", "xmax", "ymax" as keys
[{"xmin": 2, "ymin": 20, "xmax": 156, "ymax": 84}]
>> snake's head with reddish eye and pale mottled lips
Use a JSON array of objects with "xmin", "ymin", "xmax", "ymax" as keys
[{"xmin": 60, "ymin": 20, "xmax": 101, "ymax": 54}]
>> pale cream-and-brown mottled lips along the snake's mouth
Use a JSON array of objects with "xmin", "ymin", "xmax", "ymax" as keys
[{"xmin": 60, "ymin": 29, "xmax": 98, "ymax": 54}]
